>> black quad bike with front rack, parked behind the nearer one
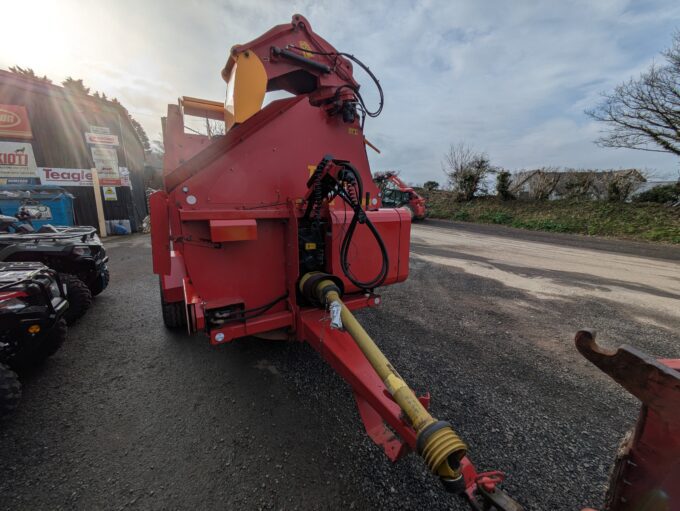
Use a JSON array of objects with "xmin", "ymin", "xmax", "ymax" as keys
[{"xmin": 0, "ymin": 216, "xmax": 109, "ymax": 324}]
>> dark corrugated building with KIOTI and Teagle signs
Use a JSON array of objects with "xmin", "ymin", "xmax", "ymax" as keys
[{"xmin": 0, "ymin": 70, "xmax": 147, "ymax": 231}]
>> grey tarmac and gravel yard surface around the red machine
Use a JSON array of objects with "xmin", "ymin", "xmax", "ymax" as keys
[{"xmin": 0, "ymin": 225, "xmax": 680, "ymax": 511}]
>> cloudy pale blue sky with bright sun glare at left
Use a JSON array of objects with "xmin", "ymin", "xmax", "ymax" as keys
[{"xmin": 0, "ymin": 0, "xmax": 680, "ymax": 183}]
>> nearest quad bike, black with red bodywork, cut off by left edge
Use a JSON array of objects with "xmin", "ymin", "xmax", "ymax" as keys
[{"xmin": 0, "ymin": 262, "xmax": 69, "ymax": 417}]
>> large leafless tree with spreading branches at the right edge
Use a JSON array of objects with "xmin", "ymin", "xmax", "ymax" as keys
[{"xmin": 586, "ymin": 32, "xmax": 680, "ymax": 156}]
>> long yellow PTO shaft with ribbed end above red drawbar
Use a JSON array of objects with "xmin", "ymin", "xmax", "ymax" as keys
[{"xmin": 300, "ymin": 273, "xmax": 467, "ymax": 491}]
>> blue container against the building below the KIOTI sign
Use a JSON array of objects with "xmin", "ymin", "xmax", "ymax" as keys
[{"xmin": 0, "ymin": 185, "xmax": 74, "ymax": 229}]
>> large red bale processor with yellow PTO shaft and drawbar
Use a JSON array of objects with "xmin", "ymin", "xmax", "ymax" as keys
[{"xmin": 150, "ymin": 15, "xmax": 680, "ymax": 510}]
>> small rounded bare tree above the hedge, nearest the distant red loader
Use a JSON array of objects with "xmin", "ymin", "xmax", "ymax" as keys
[{"xmin": 442, "ymin": 142, "xmax": 494, "ymax": 201}]
